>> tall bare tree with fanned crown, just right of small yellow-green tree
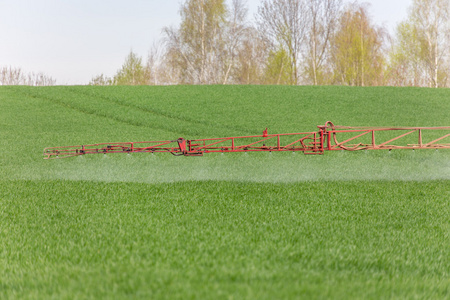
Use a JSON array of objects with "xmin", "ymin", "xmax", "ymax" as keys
[{"xmin": 257, "ymin": 0, "xmax": 307, "ymax": 84}]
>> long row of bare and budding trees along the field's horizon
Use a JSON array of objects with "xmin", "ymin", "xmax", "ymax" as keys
[{"xmin": 94, "ymin": 0, "xmax": 450, "ymax": 87}]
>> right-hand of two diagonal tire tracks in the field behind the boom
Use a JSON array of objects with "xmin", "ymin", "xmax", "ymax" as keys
[{"xmin": 68, "ymin": 88, "xmax": 260, "ymax": 134}]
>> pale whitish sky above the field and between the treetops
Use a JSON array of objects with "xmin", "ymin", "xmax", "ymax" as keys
[{"xmin": 0, "ymin": 0, "xmax": 412, "ymax": 85}]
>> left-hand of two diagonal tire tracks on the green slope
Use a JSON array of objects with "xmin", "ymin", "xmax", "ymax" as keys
[{"xmin": 19, "ymin": 88, "xmax": 187, "ymax": 135}]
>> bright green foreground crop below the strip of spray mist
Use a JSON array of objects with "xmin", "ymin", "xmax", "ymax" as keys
[{"xmin": 0, "ymin": 181, "xmax": 450, "ymax": 299}]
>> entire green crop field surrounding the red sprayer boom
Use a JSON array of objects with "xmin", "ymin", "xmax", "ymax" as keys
[{"xmin": 0, "ymin": 86, "xmax": 450, "ymax": 299}]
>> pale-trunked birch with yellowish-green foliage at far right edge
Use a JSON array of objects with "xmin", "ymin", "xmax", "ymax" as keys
[{"xmin": 390, "ymin": 0, "xmax": 450, "ymax": 87}]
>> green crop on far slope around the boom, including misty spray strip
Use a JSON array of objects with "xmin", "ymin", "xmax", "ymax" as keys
[{"xmin": 0, "ymin": 86, "xmax": 450, "ymax": 183}]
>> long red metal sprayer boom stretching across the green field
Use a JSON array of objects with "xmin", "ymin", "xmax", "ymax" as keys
[{"xmin": 44, "ymin": 121, "xmax": 450, "ymax": 159}]
